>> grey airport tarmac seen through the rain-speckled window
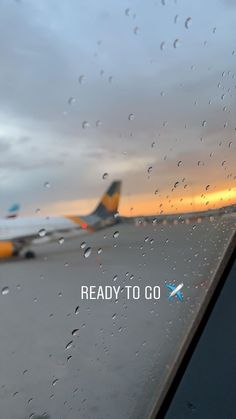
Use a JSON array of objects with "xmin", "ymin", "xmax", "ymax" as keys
[{"xmin": 0, "ymin": 216, "xmax": 235, "ymax": 419}]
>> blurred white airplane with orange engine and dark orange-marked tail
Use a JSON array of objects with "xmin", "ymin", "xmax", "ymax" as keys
[{"xmin": 0, "ymin": 181, "xmax": 121, "ymax": 259}]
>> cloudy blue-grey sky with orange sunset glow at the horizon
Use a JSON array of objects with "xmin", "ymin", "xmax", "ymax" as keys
[{"xmin": 0, "ymin": 0, "xmax": 236, "ymax": 215}]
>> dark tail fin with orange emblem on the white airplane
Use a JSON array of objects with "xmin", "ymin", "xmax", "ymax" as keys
[{"xmin": 93, "ymin": 180, "xmax": 121, "ymax": 218}]
